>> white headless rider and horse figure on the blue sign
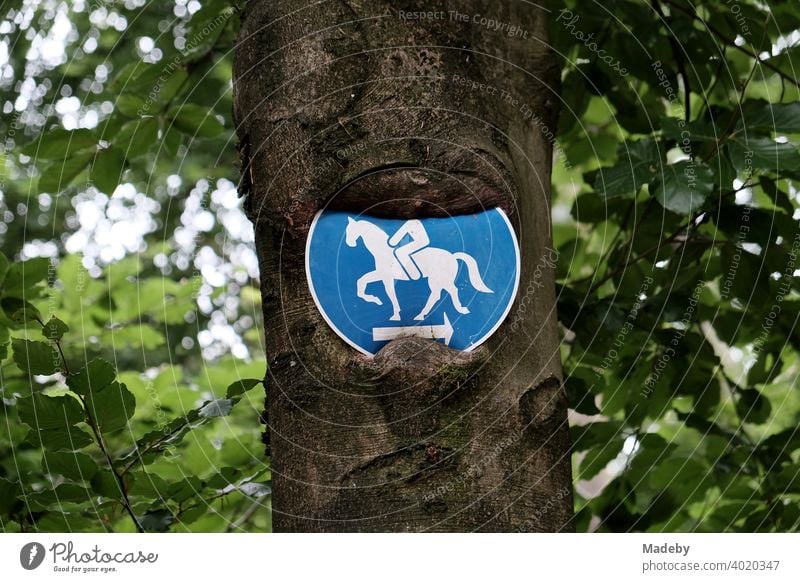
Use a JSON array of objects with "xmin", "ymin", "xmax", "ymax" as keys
[{"xmin": 345, "ymin": 217, "xmax": 493, "ymax": 321}]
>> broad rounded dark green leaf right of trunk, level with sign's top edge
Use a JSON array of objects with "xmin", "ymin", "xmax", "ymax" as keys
[{"xmin": 655, "ymin": 160, "xmax": 714, "ymax": 214}]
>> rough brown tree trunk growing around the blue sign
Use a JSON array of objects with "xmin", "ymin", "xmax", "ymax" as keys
[{"xmin": 234, "ymin": 0, "xmax": 572, "ymax": 531}]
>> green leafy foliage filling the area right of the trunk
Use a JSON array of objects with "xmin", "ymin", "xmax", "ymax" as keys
[{"xmin": 549, "ymin": 0, "xmax": 800, "ymax": 531}]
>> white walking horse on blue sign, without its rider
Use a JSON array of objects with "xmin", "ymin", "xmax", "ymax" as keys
[{"xmin": 345, "ymin": 217, "xmax": 493, "ymax": 321}]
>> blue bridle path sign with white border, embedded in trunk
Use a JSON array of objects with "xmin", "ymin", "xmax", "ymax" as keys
[{"xmin": 306, "ymin": 208, "xmax": 520, "ymax": 356}]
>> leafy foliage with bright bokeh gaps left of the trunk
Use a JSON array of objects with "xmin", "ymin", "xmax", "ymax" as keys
[{"xmin": 0, "ymin": 0, "xmax": 270, "ymax": 531}]
